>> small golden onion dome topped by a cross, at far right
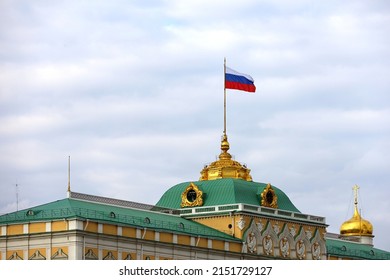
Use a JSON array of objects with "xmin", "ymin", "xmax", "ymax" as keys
[{"xmin": 340, "ymin": 186, "xmax": 373, "ymax": 236}]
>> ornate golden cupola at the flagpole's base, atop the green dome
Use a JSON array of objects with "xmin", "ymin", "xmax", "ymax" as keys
[{"xmin": 199, "ymin": 133, "xmax": 252, "ymax": 181}]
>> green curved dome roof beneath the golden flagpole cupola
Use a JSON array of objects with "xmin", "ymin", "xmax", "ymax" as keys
[{"xmin": 156, "ymin": 178, "xmax": 300, "ymax": 213}]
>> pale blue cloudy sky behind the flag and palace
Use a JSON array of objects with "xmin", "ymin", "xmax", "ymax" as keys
[{"xmin": 0, "ymin": 0, "xmax": 390, "ymax": 251}]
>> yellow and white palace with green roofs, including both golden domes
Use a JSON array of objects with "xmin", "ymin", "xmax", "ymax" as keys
[{"xmin": 0, "ymin": 133, "xmax": 390, "ymax": 260}]
